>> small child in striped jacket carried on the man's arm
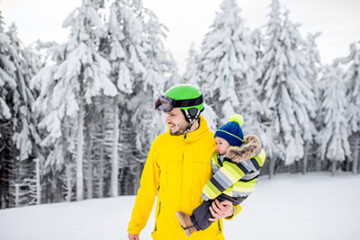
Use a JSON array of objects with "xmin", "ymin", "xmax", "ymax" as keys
[{"xmin": 176, "ymin": 114, "xmax": 266, "ymax": 237}]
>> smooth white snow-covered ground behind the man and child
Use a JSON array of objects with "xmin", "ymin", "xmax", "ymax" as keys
[{"xmin": 0, "ymin": 173, "xmax": 360, "ymax": 240}]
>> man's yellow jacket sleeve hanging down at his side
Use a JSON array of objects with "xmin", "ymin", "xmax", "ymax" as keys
[{"xmin": 127, "ymin": 141, "xmax": 160, "ymax": 235}]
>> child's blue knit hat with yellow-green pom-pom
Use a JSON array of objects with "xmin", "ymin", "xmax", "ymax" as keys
[{"xmin": 214, "ymin": 114, "xmax": 244, "ymax": 146}]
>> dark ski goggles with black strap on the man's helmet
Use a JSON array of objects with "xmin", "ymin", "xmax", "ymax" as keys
[{"xmin": 155, "ymin": 95, "xmax": 203, "ymax": 112}]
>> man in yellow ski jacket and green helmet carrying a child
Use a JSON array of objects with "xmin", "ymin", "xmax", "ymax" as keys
[{"xmin": 128, "ymin": 85, "xmax": 240, "ymax": 240}]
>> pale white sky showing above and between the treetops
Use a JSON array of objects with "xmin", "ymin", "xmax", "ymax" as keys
[{"xmin": 0, "ymin": 0, "xmax": 360, "ymax": 70}]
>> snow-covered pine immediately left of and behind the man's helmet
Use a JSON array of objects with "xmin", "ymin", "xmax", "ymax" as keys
[{"xmin": 128, "ymin": 3, "xmax": 175, "ymax": 193}]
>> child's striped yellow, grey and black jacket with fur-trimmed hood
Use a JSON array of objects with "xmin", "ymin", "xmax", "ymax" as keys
[{"xmin": 202, "ymin": 135, "xmax": 266, "ymax": 201}]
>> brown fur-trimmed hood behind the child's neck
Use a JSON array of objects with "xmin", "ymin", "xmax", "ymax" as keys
[{"xmin": 226, "ymin": 135, "xmax": 262, "ymax": 163}]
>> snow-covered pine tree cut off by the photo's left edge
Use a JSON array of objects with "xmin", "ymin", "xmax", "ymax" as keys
[{"xmin": 0, "ymin": 14, "xmax": 42, "ymax": 207}]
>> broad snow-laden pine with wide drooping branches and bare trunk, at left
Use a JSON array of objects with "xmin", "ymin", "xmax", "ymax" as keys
[{"xmin": 32, "ymin": 0, "xmax": 117, "ymax": 200}]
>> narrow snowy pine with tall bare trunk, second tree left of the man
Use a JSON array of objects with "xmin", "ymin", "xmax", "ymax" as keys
[{"xmin": 105, "ymin": 0, "xmax": 134, "ymax": 196}]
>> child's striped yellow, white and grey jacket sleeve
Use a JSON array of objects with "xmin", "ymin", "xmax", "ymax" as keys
[{"xmin": 202, "ymin": 161, "xmax": 248, "ymax": 201}]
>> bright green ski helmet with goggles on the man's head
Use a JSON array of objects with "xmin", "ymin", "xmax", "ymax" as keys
[{"xmin": 155, "ymin": 84, "xmax": 204, "ymax": 123}]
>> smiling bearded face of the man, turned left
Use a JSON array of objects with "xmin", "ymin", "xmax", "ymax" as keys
[{"xmin": 166, "ymin": 108, "xmax": 189, "ymax": 136}]
